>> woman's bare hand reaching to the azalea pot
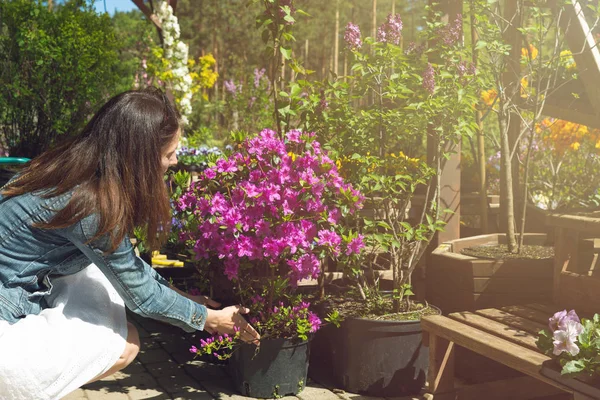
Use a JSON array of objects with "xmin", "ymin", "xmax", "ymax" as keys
[{"xmin": 204, "ymin": 306, "xmax": 260, "ymax": 344}]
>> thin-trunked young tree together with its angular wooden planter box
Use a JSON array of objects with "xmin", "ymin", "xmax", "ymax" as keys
[{"xmin": 427, "ymin": 1, "xmax": 589, "ymax": 312}]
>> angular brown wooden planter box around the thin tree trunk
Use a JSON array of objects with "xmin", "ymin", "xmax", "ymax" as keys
[{"xmin": 426, "ymin": 233, "xmax": 554, "ymax": 313}]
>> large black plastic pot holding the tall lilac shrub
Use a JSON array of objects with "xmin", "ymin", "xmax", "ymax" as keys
[{"xmin": 309, "ymin": 306, "xmax": 440, "ymax": 397}]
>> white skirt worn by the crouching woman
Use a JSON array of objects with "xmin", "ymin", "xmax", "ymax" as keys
[{"xmin": 0, "ymin": 264, "xmax": 127, "ymax": 400}]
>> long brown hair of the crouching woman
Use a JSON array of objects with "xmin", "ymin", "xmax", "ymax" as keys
[{"xmin": 3, "ymin": 88, "xmax": 180, "ymax": 251}]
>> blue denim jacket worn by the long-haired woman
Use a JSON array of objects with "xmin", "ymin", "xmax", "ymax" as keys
[{"xmin": 0, "ymin": 188, "xmax": 207, "ymax": 332}]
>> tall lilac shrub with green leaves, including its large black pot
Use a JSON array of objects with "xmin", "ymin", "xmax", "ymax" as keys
[{"xmin": 296, "ymin": 10, "xmax": 475, "ymax": 397}]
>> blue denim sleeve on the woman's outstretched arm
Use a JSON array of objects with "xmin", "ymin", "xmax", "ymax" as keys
[{"xmin": 60, "ymin": 216, "xmax": 207, "ymax": 332}]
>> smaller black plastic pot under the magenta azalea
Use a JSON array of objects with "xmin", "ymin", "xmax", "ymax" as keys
[{"xmin": 229, "ymin": 339, "xmax": 309, "ymax": 398}]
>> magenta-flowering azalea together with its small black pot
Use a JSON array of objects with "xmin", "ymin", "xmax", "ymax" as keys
[{"xmin": 176, "ymin": 129, "xmax": 363, "ymax": 397}]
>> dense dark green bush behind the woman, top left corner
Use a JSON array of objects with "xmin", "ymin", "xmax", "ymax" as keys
[{"xmin": 0, "ymin": 0, "xmax": 119, "ymax": 157}]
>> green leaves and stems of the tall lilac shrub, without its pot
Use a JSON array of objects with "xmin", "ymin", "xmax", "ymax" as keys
[{"xmin": 289, "ymin": 10, "xmax": 475, "ymax": 310}]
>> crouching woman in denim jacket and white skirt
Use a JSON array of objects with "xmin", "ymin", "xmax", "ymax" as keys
[{"xmin": 0, "ymin": 89, "xmax": 259, "ymax": 400}]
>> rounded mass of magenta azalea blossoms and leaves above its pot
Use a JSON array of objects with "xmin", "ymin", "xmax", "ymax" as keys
[{"xmin": 176, "ymin": 129, "xmax": 363, "ymax": 312}]
